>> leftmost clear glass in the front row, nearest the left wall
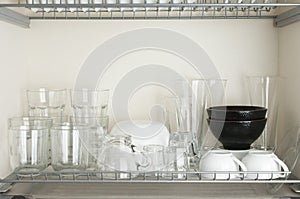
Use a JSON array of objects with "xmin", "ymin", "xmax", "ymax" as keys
[{"xmin": 8, "ymin": 117, "xmax": 52, "ymax": 174}]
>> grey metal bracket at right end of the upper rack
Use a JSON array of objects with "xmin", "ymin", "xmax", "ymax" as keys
[{"xmin": 274, "ymin": 6, "xmax": 300, "ymax": 27}]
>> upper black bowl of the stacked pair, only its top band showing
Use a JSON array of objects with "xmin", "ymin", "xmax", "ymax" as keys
[{"xmin": 207, "ymin": 105, "xmax": 267, "ymax": 121}]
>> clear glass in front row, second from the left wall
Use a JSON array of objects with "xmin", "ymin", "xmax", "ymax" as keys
[{"xmin": 51, "ymin": 122, "xmax": 90, "ymax": 172}]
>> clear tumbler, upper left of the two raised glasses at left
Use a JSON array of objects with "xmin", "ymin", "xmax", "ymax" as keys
[{"xmin": 27, "ymin": 88, "xmax": 68, "ymax": 117}]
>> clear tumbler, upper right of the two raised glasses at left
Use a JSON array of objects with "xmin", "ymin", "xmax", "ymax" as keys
[{"xmin": 71, "ymin": 89, "xmax": 109, "ymax": 117}]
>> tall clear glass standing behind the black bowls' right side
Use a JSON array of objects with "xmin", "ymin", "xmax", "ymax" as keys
[{"xmin": 247, "ymin": 76, "xmax": 281, "ymax": 151}]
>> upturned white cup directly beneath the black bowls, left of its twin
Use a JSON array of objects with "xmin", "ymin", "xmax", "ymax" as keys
[{"xmin": 199, "ymin": 150, "xmax": 247, "ymax": 179}]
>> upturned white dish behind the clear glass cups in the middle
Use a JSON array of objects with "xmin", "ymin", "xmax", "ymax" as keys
[{"xmin": 110, "ymin": 120, "xmax": 170, "ymax": 150}]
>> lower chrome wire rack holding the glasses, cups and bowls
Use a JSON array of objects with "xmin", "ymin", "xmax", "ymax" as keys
[{"xmin": 0, "ymin": 171, "xmax": 300, "ymax": 183}]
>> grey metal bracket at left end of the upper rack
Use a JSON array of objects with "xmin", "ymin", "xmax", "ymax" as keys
[{"xmin": 0, "ymin": 8, "xmax": 30, "ymax": 28}]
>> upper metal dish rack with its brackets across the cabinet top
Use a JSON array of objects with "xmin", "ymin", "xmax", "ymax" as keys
[{"xmin": 0, "ymin": 0, "xmax": 300, "ymax": 27}]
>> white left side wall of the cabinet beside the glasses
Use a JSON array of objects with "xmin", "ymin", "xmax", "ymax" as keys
[{"xmin": 0, "ymin": 22, "xmax": 28, "ymax": 178}]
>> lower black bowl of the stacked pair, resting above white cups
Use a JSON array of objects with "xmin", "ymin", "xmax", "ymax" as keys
[{"xmin": 207, "ymin": 118, "xmax": 267, "ymax": 150}]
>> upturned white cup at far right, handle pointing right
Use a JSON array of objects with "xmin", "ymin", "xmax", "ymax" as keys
[{"xmin": 242, "ymin": 150, "xmax": 289, "ymax": 179}]
